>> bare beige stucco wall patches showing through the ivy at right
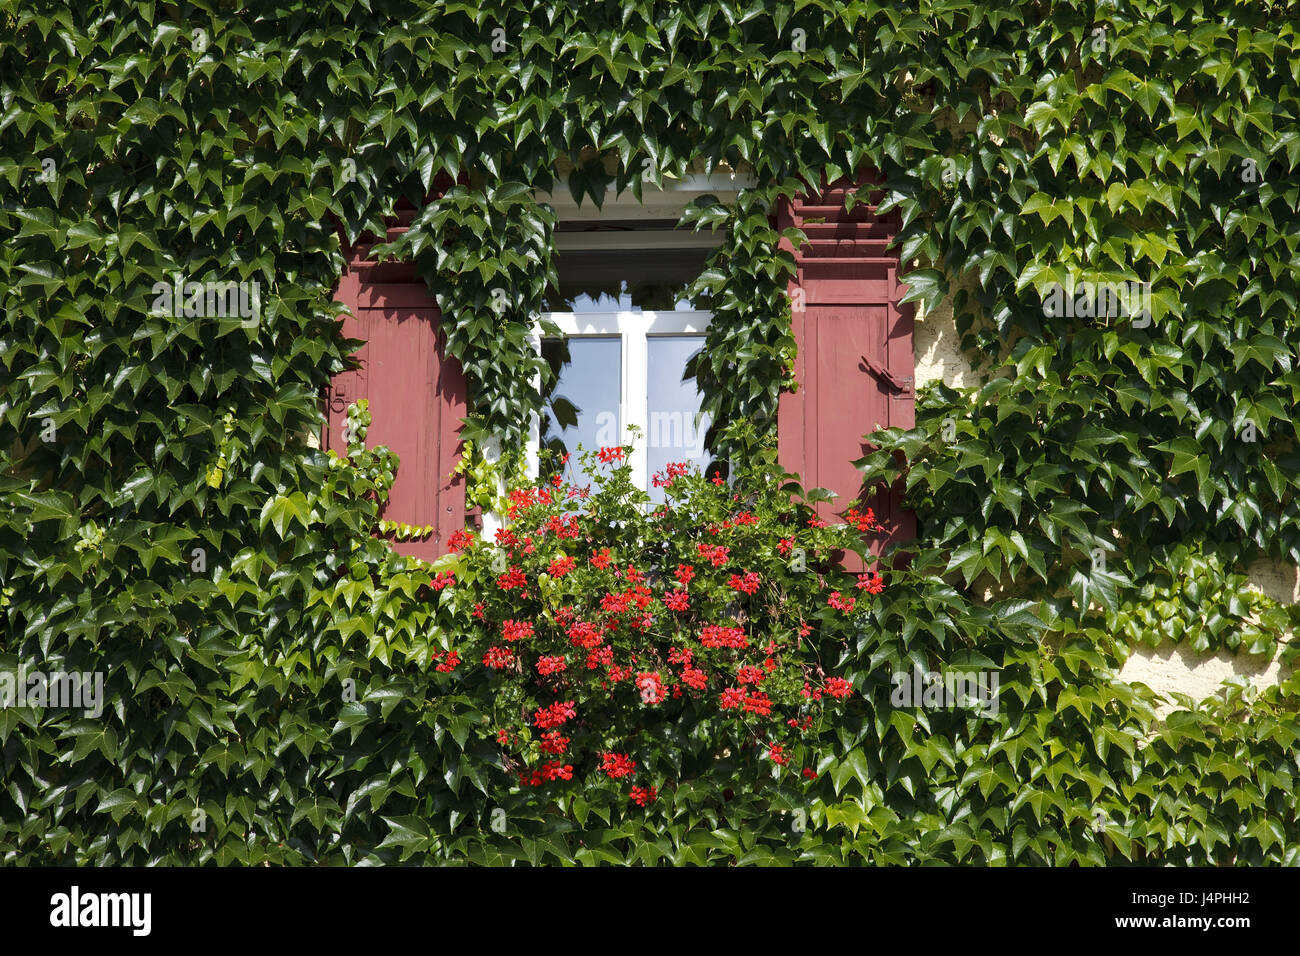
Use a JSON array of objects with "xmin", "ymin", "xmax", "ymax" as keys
[{"xmin": 914, "ymin": 300, "xmax": 1300, "ymax": 713}]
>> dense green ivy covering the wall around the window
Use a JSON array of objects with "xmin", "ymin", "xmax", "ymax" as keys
[{"xmin": 0, "ymin": 0, "xmax": 1300, "ymax": 864}]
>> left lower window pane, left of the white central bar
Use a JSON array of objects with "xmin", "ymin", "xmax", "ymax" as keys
[{"xmin": 541, "ymin": 336, "xmax": 624, "ymax": 483}]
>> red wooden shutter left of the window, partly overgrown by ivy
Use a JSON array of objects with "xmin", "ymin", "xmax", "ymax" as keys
[{"xmin": 322, "ymin": 201, "xmax": 467, "ymax": 561}]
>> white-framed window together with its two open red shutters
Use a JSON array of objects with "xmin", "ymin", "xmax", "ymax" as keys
[{"xmin": 324, "ymin": 177, "xmax": 915, "ymax": 559}]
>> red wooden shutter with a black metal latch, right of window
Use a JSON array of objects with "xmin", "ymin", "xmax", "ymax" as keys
[{"xmin": 777, "ymin": 172, "xmax": 917, "ymax": 570}]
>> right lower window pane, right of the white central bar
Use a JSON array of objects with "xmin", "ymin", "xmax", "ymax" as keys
[{"xmin": 646, "ymin": 336, "xmax": 709, "ymax": 501}]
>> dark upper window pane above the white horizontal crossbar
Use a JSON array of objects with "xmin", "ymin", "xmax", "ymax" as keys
[{"xmin": 543, "ymin": 248, "xmax": 712, "ymax": 312}]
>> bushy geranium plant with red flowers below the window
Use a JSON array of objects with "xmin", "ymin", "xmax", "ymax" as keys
[{"xmin": 430, "ymin": 429, "xmax": 884, "ymax": 806}]
